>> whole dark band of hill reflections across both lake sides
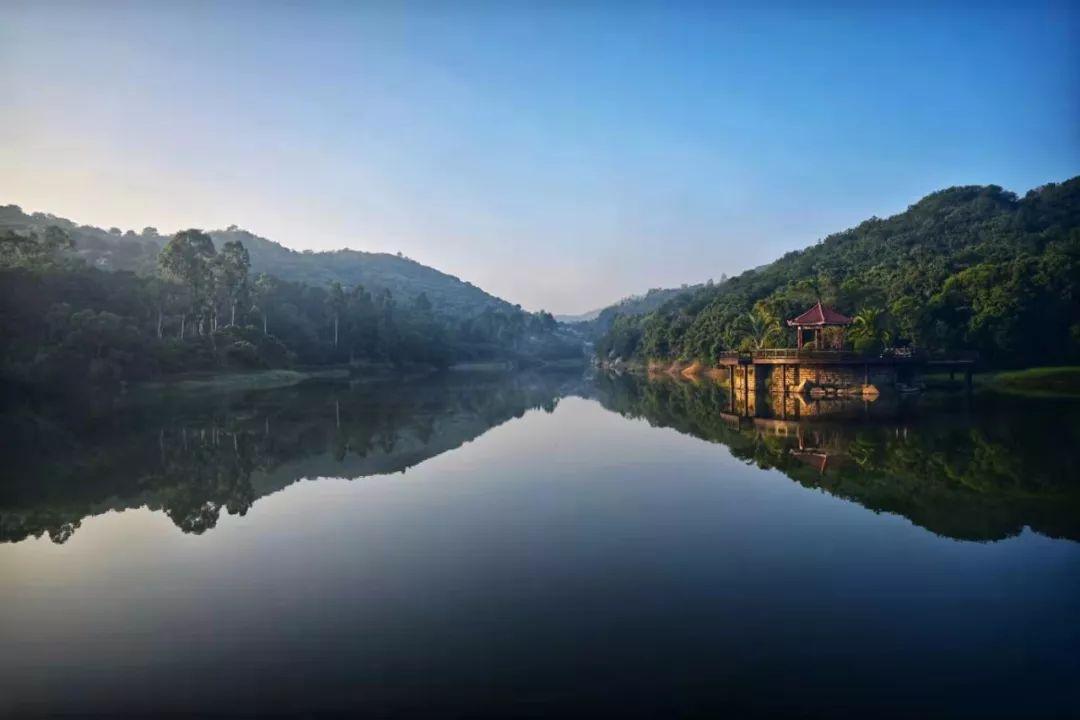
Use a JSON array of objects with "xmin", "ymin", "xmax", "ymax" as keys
[{"xmin": 0, "ymin": 373, "xmax": 1080, "ymax": 543}]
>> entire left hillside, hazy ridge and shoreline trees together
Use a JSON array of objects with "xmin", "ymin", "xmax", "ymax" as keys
[{"xmin": 0, "ymin": 206, "xmax": 584, "ymax": 394}]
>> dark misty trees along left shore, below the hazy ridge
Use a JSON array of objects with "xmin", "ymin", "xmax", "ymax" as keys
[{"xmin": 0, "ymin": 226, "xmax": 581, "ymax": 397}]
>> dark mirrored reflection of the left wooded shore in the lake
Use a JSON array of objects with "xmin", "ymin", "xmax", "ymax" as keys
[{"xmin": 0, "ymin": 375, "xmax": 580, "ymax": 543}]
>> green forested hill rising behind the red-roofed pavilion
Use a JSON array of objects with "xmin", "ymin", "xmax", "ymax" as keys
[{"xmin": 597, "ymin": 177, "xmax": 1080, "ymax": 367}]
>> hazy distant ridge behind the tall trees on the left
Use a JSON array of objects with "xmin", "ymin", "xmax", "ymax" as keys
[{"xmin": 0, "ymin": 205, "xmax": 512, "ymax": 317}]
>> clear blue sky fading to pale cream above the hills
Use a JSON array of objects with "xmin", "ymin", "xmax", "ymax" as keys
[{"xmin": 0, "ymin": 0, "xmax": 1080, "ymax": 313}]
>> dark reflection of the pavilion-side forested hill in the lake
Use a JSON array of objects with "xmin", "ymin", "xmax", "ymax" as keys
[{"xmin": 597, "ymin": 377, "xmax": 1080, "ymax": 540}]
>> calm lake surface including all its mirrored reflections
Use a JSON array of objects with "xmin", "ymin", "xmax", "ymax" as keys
[{"xmin": 0, "ymin": 375, "xmax": 1080, "ymax": 718}]
